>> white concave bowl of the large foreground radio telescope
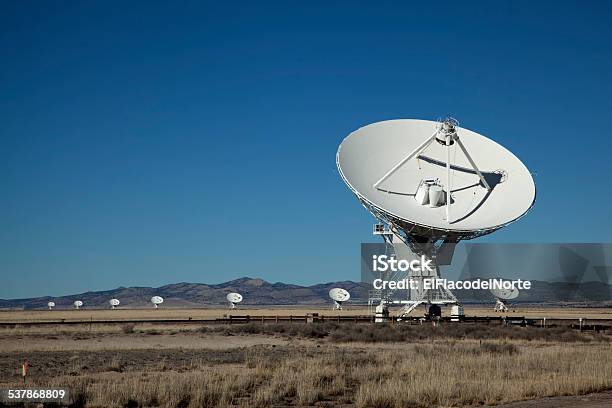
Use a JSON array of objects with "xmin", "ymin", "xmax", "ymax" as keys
[{"xmin": 337, "ymin": 119, "xmax": 536, "ymax": 238}]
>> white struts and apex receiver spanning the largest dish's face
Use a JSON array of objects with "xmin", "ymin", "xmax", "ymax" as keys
[{"xmin": 374, "ymin": 118, "xmax": 491, "ymax": 224}]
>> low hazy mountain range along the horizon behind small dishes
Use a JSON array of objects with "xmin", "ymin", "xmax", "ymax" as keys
[{"xmin": 0, "ymin": 277, "xmax": 612, "ymax": 309}]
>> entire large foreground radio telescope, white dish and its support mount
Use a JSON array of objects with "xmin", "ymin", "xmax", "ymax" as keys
[{"xmin": 336, "ymin": 118, "xmax": 536, "ymax": 317}]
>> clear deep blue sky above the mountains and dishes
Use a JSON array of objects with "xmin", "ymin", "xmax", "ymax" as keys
[{"xmin": 0, "ymin": 1, "xmax": 612, "ymax": 298}]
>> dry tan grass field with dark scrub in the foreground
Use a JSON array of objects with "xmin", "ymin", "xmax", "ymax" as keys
[{"xmin": 0, "ymin": 323, "xmax": 612, "ymax": 408}]
